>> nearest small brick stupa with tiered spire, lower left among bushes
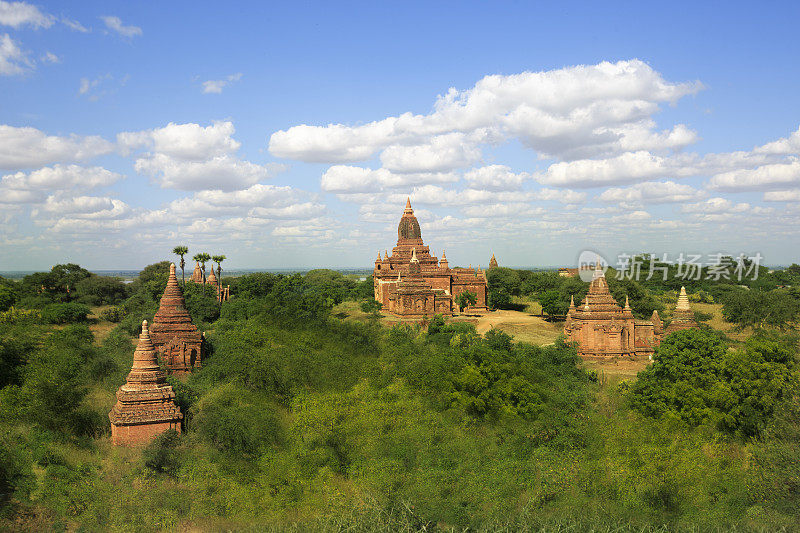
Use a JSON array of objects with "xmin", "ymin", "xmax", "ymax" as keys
[{"xmin": 108, "ymin": 320, "xmax": 183, "ymax": 446}]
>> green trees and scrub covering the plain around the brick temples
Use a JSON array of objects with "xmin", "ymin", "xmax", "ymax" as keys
[{"xmin": 0, "ymin": 263, "xmax": 800, "ymax": 531}]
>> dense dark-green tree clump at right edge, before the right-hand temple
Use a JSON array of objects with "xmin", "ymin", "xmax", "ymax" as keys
[{"xmin": 629, "ymin": 329, "xmax": 798, "ymax": 436}]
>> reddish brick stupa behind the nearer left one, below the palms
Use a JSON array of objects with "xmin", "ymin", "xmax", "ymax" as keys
[{"xmin": 151, "ymin": 263, "xmax": 203, "ymax": 374}]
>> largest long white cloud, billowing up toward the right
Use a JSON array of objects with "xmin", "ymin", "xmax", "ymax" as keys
[{"xmin": 269, "ymin": 60, "xmax": 702, "ymax": 163}]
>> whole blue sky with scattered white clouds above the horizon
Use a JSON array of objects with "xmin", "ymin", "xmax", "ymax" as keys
[{"xmin": 0, "ymin": 1, "xmax": 800, "ymax": 270}]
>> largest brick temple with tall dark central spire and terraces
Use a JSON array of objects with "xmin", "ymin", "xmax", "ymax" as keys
[{"xmin": 372, "ymin": 199, "xmax": 488, "ymax": 319}]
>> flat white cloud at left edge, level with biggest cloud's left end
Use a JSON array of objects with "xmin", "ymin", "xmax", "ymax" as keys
[{"xmin": 0, "ymin": 125, "xmax": 113, "ymax": 170}]
